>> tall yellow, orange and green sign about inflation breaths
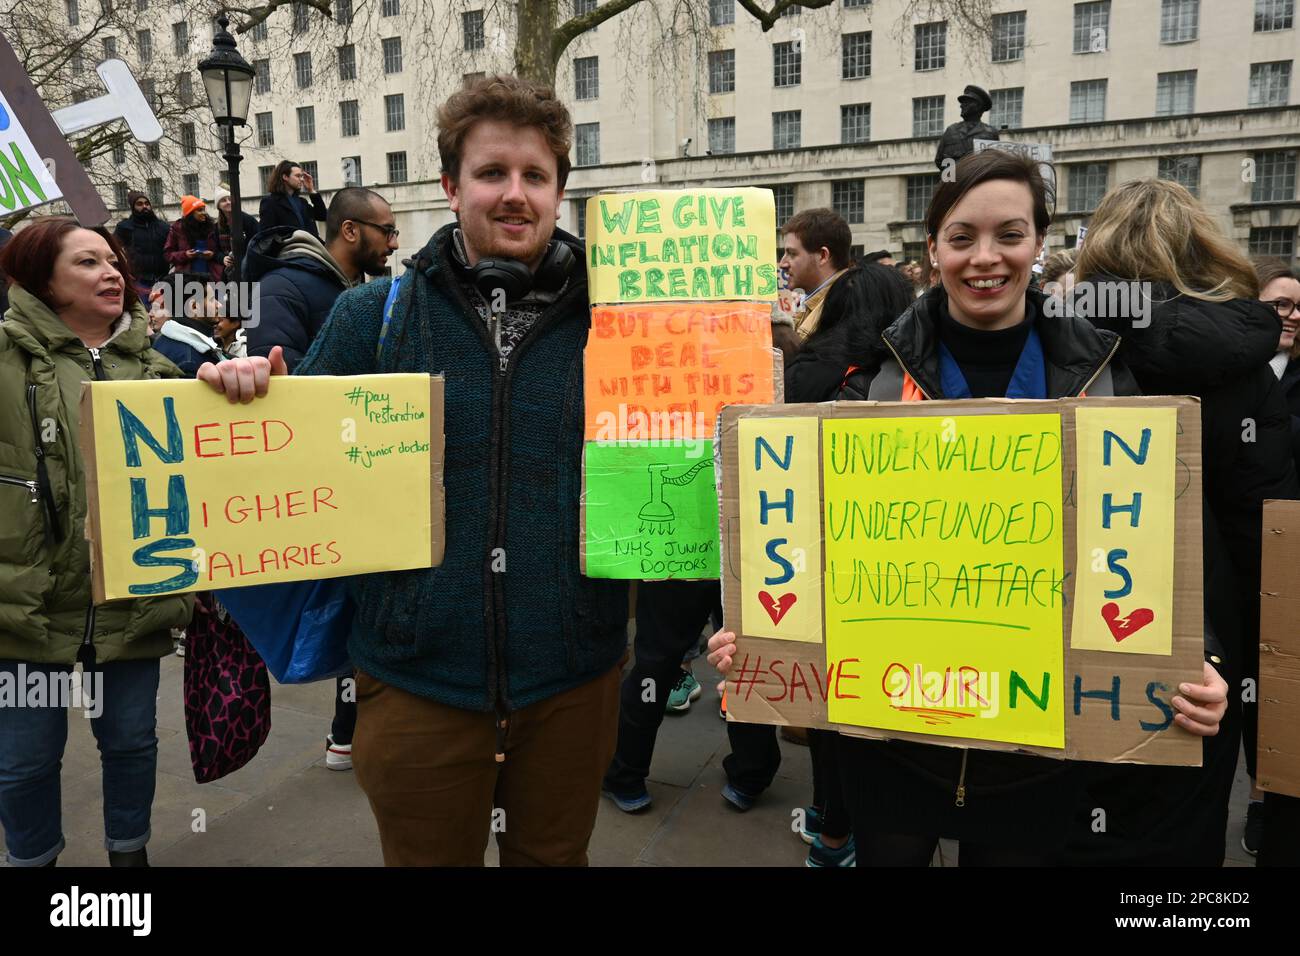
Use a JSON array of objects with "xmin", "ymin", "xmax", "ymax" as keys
[{"xmin": 580, "ymin": 189, "xmax": 780, "ymax": 580}]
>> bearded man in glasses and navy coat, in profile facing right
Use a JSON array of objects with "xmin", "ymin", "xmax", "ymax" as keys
[{"xmin": 243, "ymin": 186, "xmax": 398, "ymax": 770}]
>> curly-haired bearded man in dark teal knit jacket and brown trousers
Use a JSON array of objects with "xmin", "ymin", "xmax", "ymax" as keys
[{"xmin": 200, "ymin": 77, "xmax": 628, "ymax": 866}]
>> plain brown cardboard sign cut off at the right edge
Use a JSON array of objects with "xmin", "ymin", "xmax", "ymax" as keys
[{"xmin": 1256, "ymin": 501, "xmax": 1300, "ymax": 797}]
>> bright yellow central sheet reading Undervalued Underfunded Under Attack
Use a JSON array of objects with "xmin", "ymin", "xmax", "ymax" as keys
[{"xmin": 822, "ymin": 414, "xmax": 1066, "ymax": 748}]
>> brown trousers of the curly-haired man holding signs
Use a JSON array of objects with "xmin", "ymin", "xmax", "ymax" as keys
[{"xmin": 352, "ymin": 667, "xmax": 621, "ymax": 866}]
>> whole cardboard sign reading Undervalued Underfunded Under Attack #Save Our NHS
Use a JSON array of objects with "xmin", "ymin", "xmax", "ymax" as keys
[{"xmin": 720, "ymin": 397, "xmax": 1204, "ymax": 765}]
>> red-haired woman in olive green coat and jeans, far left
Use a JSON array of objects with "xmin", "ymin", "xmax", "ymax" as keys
[{"xmin": 0, "ymin": 217, "xmax": 191, "ymax": 866}]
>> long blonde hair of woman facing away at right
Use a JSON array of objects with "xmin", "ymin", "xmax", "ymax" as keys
[{"xmin": 1074, "ymin": 179, "xmax": 1260, "ymax": 302}]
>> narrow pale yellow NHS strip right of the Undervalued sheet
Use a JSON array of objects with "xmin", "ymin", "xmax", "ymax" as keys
[{"xmin": 1070, "ymin": 407, "xmax": 1178, "ymax": 656}]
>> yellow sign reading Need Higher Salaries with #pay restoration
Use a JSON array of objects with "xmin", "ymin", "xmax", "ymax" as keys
[{"xmin": 81, "ymin": 375, "xmax": 446, "ymax": 604}]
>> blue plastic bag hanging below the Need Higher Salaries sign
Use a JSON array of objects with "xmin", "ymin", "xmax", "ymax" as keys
[{"xmin": 216, "ymin": 578, "xmax": 355, "ymax": 684}]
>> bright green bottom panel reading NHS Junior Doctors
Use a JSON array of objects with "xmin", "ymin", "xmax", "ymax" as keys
[{"xmin": 584, "ymin": 440, "xmax": 719, "ymax": 580}]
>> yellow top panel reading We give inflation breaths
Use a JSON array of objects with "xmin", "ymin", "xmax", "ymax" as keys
[{"xmin": 586, "ymin": 187, "xmax": 779, "ymax": 304}]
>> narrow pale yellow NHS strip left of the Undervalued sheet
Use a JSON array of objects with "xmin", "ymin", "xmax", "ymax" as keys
[{"xmin": 737, "ymin": 418, "xmax": 822, "ymax": 644}]
